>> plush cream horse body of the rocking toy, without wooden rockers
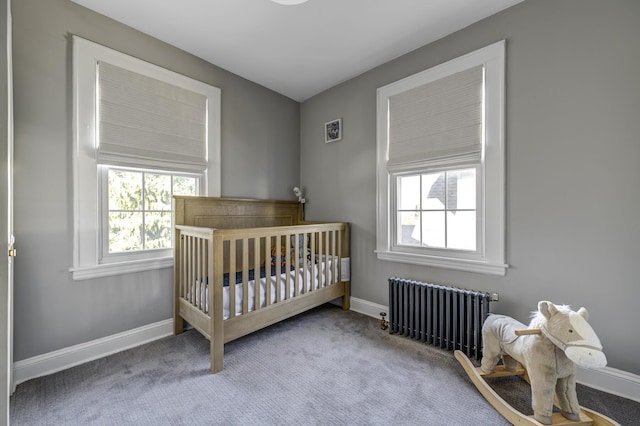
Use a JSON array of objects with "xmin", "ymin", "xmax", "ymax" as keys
[{"xmin": 480, "ymin": 301, "xmax": 607, "ymax": 424}]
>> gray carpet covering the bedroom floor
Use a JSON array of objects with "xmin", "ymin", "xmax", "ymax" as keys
[{"xmin": 10, "ymin": 305, "xmax": 640, "ymax": 425}]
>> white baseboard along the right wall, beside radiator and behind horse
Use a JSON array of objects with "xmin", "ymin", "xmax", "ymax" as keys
[{"xmin": 350, "ymin": 297, "xmax": 640, "ymax": 402}]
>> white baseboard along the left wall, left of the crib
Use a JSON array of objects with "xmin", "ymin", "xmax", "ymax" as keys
[{"xmin": 12, "ymin": 319, "xmax": 173, "ymax": 391}]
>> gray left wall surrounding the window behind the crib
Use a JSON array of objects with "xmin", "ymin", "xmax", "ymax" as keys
[{"xmin": 12, "ymin": 0, "xmax": 300, "ymax": 361}]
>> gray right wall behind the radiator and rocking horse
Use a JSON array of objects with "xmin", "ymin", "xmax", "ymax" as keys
[{"xmin": 300, "ymin": 0, "xmax": 640, "ymax": 374}]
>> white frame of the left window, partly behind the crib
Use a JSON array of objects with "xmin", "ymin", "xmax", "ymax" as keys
[{"xmin": 70, "ymin": 36, "xmax": 221, "ymax": 280}]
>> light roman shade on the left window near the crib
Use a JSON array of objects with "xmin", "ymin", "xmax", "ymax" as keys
[{"xmin": 97, "ymin": 61, "xmax": 207, "ymax": 170}]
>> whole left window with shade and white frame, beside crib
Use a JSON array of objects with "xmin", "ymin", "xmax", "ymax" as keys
[{"xmin": 71, "ymin": 36, "xmax": 220, "ymax": 279}]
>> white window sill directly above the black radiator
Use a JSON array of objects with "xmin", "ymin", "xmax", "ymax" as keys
[{"xmin": 376, "ymin": 251, "xmax": 509, "ymax": 276}]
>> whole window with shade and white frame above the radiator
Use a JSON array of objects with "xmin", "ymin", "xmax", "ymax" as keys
[{"xmin": 376, "ymin": 42, "xmax": 507, "ymax": 275}]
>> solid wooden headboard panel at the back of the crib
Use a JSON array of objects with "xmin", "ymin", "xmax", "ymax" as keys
[{"xmin": 174, "ymin": 196, "xmax": 302, "ymax": 229}]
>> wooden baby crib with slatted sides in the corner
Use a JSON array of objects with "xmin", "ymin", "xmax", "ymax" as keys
[{"xmin": 173, "ymin": 196, "xmax": 349, "ymax": 373}]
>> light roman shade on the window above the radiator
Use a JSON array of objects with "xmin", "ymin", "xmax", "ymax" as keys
[{"xmin": 387, "ymin": 65, "xmax": 484, "ymax": 168}]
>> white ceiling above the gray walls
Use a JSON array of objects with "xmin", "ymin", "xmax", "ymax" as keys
[{"xmin": 72, "ymin": 0, "xmax": 523, "ymax": 101}]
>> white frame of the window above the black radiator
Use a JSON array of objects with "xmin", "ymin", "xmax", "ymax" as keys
[{"xmin": 376, "ymin": 40, "xmax": 508, "ymax": 276}]
